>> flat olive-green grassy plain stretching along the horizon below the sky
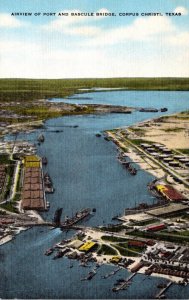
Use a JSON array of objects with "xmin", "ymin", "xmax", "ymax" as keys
[{"xmin": 0, "ymin": 78, "xmax": 189, "ymax": 102}]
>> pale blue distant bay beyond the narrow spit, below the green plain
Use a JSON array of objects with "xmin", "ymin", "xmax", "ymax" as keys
[{"xmin": 50, "ymin": 91, "xmax": 189, "ymax": 113}]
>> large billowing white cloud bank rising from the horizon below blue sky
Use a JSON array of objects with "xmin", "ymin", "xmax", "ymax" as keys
[{"xmin": 0, "ymin": 12, "xmax": 189, "ymax": 78}]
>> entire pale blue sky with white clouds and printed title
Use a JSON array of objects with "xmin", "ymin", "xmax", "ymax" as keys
[{"xmin": 0, "ymin": 0, "xmax": 189, "ymax": 78}]
